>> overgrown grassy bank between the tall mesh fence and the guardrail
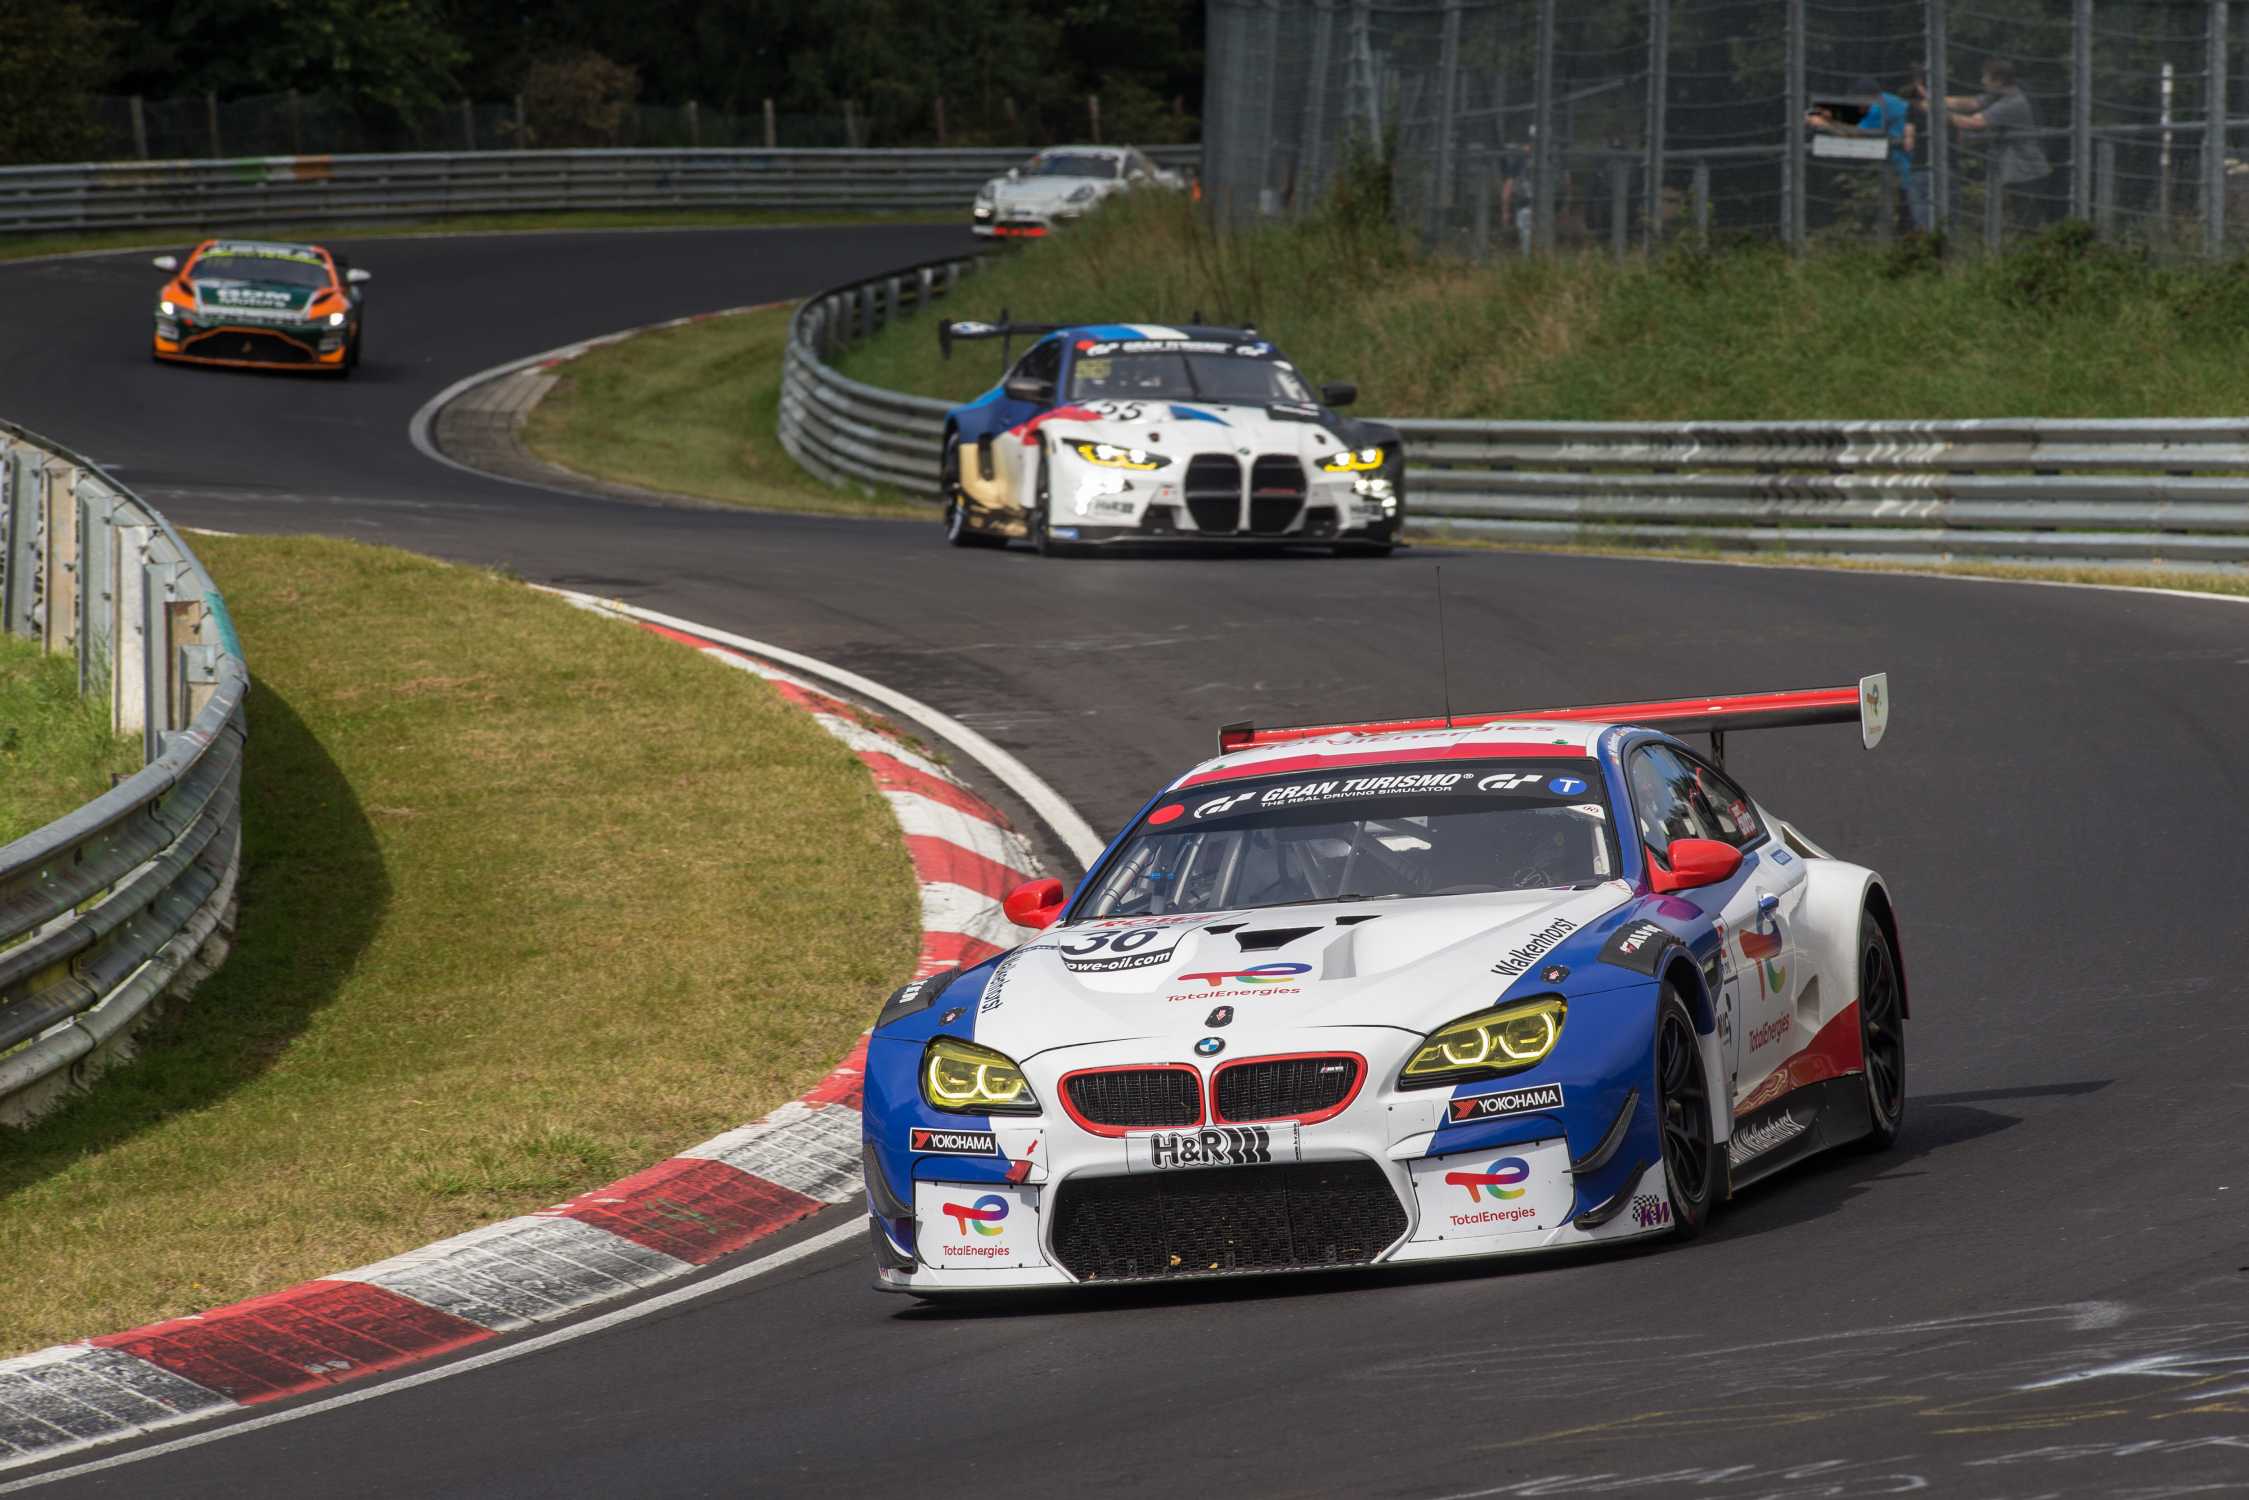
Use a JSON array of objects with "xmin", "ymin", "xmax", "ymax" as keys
[{"xmin": 841, "ymin": 193, "xmax": 2249, "ymax": 421}]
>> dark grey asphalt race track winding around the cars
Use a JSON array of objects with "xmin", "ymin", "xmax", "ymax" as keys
[{"xmin": 0, "ymin": 229, "xmax": 2249, "ymax": 1500}]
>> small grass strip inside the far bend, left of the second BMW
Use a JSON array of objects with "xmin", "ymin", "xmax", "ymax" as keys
[{"xmin": 522, "ymin": 308, "xmax": 938, "ymax": 519}]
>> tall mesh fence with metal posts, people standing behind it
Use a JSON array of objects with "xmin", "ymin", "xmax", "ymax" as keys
[{"xmin": 1203, "ymin": 0, "xmax": 2249, "ymax": 259}]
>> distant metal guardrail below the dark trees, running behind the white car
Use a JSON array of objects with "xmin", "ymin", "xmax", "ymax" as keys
[{"xmin": 0, "ymin": 146, "xmax": 1201, "ymax": 234}]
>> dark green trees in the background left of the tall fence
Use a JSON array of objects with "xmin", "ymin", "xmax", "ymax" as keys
[{"xmin": 0, "ymin": 0, "xmax": 1203, "ymax": 162}]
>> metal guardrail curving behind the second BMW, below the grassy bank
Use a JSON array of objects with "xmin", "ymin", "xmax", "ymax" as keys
[{"xmin": 780, "ymin": 259, "xmax": 2249, "ymax": 564}]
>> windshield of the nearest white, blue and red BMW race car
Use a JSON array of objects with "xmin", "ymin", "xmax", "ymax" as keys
[{"xmin": 1073, "ymin": 758, "xmax": 1617, "ymax": 920}]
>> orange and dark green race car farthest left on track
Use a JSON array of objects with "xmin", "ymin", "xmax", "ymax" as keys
[{"xmin": 151, "ymin": 241, "xmax": 367, "ymax": 378}]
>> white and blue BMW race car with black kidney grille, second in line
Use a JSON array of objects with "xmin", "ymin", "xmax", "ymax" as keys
[{"xmin": 938, "ymin": 313, "xmax": 1406, "ymax": 555}]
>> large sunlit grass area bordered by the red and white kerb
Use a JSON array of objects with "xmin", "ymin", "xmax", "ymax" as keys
[{"xmin": 0, "ymin": 537, "xmax": 920, "ymax": 1354}]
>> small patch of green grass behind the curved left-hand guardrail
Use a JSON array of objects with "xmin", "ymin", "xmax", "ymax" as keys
[{"xmin": 0, "ymin": 634, "xmax": 142, "ymax": 843}]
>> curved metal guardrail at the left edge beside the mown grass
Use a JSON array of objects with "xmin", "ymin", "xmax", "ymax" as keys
[{"xmin": 0, "ymin": 423, "xmax": 250, "ymax": 1124}]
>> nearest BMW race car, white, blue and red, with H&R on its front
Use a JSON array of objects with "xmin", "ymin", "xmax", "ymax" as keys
[{"xmin": 864, "ymin": 677, "xmax": 1905, "ymax": 1293}]
